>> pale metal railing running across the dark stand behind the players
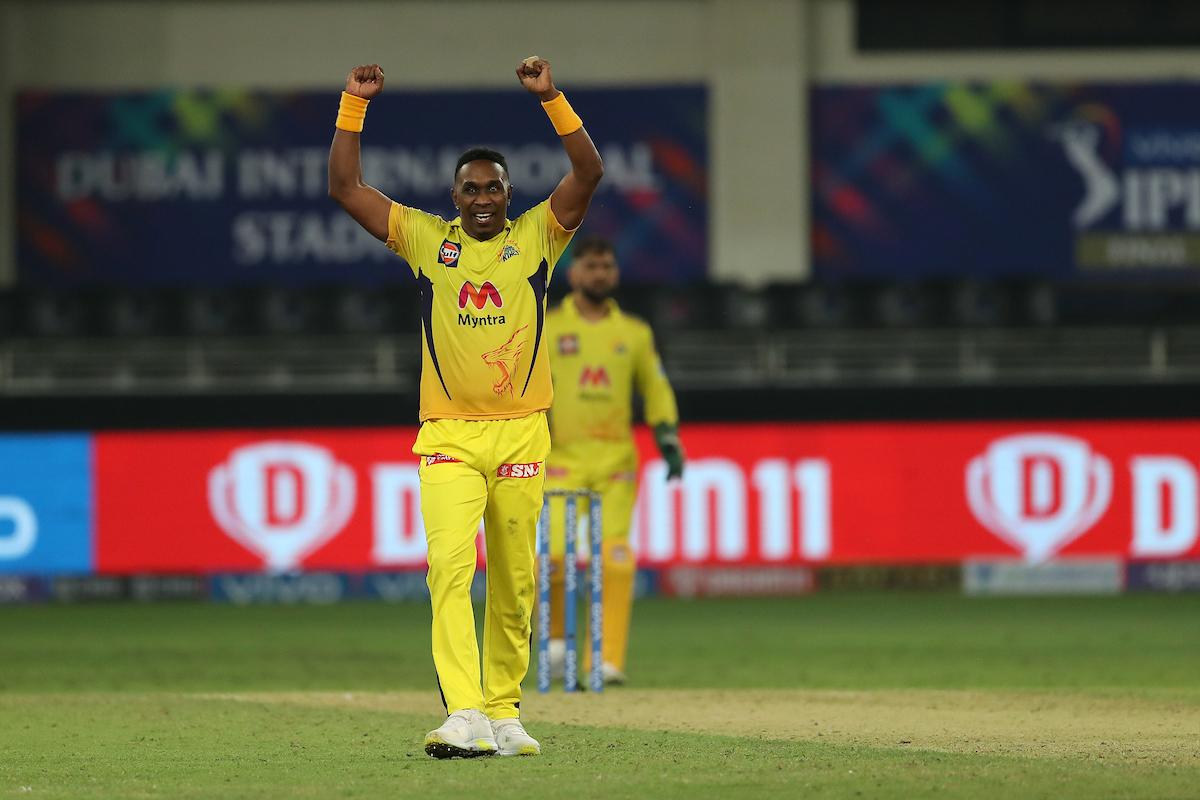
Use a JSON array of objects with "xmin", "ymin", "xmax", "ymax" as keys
[{"xmin": 0, "ymin": 326, "xmax": 1200, "ymax": 396}]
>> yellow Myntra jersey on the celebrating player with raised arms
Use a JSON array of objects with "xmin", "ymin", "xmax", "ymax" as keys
[{"xmin": 388, "ymin": 200, "xmax": 574, "ymax": 422}]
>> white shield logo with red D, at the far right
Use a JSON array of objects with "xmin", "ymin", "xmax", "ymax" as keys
[{"xmin": 966, "ymin": 433, "xmax": 1112, "ymax": 561}]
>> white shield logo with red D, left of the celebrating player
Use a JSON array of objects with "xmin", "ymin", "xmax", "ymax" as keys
[{"xmin": 209, "ymin": 441, "xmax": 355, "ymax": 570}]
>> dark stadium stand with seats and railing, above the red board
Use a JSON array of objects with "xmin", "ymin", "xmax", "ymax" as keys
[{"xmin": 0, "ymin": 282, "xmax": 1200, "ymax": 428}]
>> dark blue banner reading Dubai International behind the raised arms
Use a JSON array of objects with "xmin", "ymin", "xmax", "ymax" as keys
[{"xmin": 17, "ymin": 86, "xmax": 708, "ymax": 285}]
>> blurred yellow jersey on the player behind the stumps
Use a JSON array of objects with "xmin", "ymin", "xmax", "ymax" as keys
[{"xmin": 546, "ymin": 296, "xmax": 679, "ymax": 447}]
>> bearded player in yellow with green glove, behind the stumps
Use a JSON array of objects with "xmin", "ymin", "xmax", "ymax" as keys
[{"xmin": 546, "ymin": 237, "xmax": 684, "ymax": 684}]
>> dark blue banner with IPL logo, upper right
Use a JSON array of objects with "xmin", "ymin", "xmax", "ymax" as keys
[{"xmin": 811, "ymin": 82, "xmax": 1200, "ymax": 279}]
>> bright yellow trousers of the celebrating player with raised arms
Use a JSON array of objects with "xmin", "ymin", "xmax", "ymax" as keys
[{"xmin": 413, "ymin": 413, "xmax": 550, "ymax": 720}]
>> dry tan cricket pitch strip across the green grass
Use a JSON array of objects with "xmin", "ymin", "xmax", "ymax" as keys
[{"xmin": 204, "ymin": 688, "xmax": 1200, "ymax": 766}]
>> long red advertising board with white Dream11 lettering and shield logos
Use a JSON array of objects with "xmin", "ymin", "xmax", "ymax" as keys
[{"xmin": 95, "ymin": 421, "xmax": 1200, "ymax": 573}]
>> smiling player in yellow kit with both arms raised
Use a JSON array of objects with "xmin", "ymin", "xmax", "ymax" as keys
[{"xmin": 329, "ymin": 56, "xmax": 604, "ymax": 758}]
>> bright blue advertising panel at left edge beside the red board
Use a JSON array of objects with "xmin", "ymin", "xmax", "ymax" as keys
[{"xmin": 0, "ymin": 434, "xmax": 94, "ymax": 575}]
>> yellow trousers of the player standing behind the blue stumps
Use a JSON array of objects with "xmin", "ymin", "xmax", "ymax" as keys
[{"xmin": 546, "ymin": 440, "xmax": 637, "ymax": 670}]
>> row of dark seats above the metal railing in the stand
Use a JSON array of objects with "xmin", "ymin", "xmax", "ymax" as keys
[{"xmin": 7, "ymin": 281, "xmax": 1200, "ymax": 339}]
